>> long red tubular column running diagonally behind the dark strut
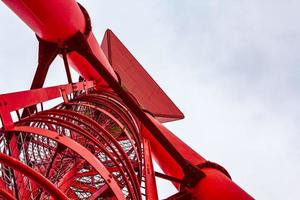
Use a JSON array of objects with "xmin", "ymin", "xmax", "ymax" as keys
[{"xmin": 3, "ymin": 0, "xmax": 253, "ymax": 200}]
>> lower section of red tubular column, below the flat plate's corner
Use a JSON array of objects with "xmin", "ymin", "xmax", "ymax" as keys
[{"xmin": 143, "ymin": 115, "xmax": 253, "ymax": 200}]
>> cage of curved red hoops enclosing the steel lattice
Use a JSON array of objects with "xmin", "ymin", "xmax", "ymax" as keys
[{"xmin": 0, "ymin": 92, "xmax": 142, "ymax": 199}]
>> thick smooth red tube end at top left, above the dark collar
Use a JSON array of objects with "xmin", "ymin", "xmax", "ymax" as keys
[{"xmin": 3, "ymin": 0, "xmax": 85, "ymax": 43}]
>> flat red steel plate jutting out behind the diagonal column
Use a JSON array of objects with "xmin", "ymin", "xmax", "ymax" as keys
[{"xmin": 101, "ymin": 30, "xmax": 184, "ymax": 122}]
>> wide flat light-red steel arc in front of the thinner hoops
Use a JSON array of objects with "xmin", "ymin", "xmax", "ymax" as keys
[{"xmin": 7, "ymin": 126, "xmax": 125, "ymax": 200}]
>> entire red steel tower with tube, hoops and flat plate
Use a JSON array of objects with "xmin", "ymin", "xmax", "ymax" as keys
[{"xmin": 0, "ymin": 0, "xmax": 253, "ymax": 200}]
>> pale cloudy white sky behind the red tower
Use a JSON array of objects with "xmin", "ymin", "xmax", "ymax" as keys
[{"xmin": 0, "ymin": 0, "xmax": 300, "ymax": 200}]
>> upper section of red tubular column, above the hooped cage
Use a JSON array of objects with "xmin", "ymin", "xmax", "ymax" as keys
[{"xmin": 3, "ymin": 0, "xmax": 117, "ymax": 86}]
